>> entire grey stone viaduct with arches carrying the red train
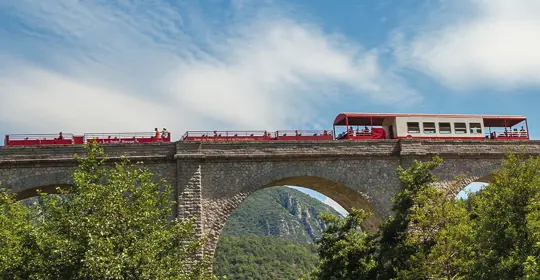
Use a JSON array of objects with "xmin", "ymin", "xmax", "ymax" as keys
[{"xmin": 0, "ymin": 140, "xmax": 540, "ymax": 260}]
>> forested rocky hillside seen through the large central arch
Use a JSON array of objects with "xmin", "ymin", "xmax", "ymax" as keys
[{"xmin": 214, "ymin": 187, "xmax": 339, "ymax": 279}]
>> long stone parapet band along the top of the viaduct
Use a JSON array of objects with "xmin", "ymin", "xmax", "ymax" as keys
[{"xmin": 0, "ymin": 140, "xmax": 540, "ymax": 165}]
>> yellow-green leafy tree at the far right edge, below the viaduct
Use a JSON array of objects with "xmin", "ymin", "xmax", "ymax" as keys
[{"xmin": 470, "ymin": 154, "xmax": 540, "ymax": 279}]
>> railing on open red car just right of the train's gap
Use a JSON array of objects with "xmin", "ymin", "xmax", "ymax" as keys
[{"xmin": 180, "ymin": 130, "xmax": 272, "ymax": 141}]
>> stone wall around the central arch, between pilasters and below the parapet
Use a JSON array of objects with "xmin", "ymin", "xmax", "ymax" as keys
[{"xmin": 202, "ymin": 158, "xmax": 399, "ymax": 258}]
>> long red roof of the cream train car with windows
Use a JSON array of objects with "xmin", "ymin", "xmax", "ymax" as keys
[{"xmin": 334, "ymin": 113, "xmax": 527, "ymax": 127}]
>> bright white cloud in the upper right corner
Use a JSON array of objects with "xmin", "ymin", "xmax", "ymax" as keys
[{"xmin": 397, "ymin": 0, "xmax": 540, "ymax": 89}]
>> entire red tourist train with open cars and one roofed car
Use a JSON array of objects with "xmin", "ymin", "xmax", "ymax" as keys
[{"xmin": 4, "ymin": 113, "xmax": 530, "ymax": 146}]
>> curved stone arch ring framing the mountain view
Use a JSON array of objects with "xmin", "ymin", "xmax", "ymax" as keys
[{"xmin": 203, "ymin": 163, "xmax": 399, "ymax": 257}]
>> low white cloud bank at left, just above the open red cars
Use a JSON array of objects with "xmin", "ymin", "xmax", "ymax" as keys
[{"xmin": 0, "ymin": 59, "xmax": 171, "ymax": 133}]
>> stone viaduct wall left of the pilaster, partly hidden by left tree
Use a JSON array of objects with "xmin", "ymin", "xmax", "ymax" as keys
[{"xmin": 0, "ymin": 143, "xmax": 177, "ymax": 200}]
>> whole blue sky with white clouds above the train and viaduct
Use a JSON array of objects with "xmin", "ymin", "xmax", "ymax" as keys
[{"xmin": 0, "ymin": 0, "xmax": 540, "ymax": 214}]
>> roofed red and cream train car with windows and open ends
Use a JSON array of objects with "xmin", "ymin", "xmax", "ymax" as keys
[{"xmin": 334, "ymin": 113, "xmax": 530, "ymax": 140}]
